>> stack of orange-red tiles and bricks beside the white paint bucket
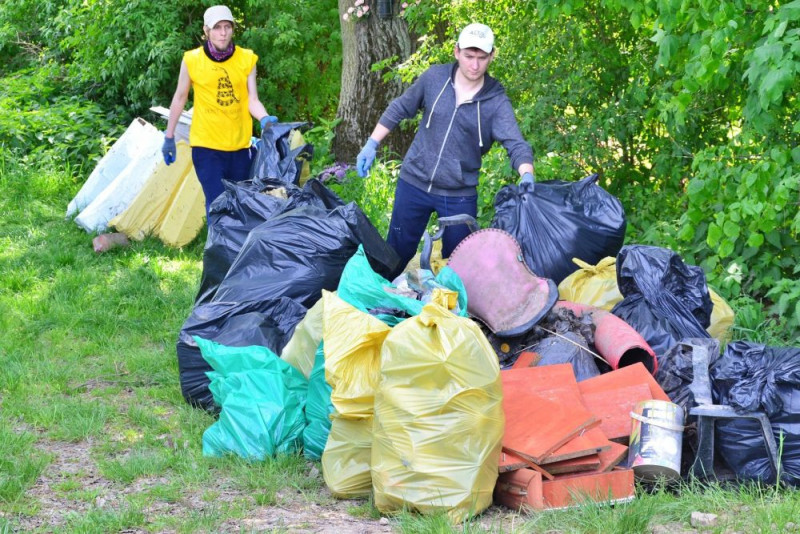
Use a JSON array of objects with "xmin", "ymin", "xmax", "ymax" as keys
[{"xmin": 495, "ymin": 356, "xmax": 669, "ymax": 510}]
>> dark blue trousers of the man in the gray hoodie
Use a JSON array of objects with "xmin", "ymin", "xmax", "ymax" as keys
[{"xmin": 386, "ymin": 180, "xmax": 478, "ymax": 274}]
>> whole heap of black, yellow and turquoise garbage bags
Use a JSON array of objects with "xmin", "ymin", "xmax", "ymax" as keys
[{"xmin": 177, "ymin": 132, "xmax": 800, "ymax": 521}]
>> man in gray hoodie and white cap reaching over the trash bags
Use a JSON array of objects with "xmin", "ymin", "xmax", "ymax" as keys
[{"xmin": 356, "ymin": 24, "xmax": 533, "ymax": 274}]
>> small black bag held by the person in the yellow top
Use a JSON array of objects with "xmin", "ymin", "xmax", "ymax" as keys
[{"xmin": 250, "ymin": 122, "xmax": 314, "ymax": 184}]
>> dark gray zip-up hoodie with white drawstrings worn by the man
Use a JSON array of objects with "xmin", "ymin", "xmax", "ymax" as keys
[{"xmin": 379, "ymin": 63, "xmax": 533, "ymax": 196}]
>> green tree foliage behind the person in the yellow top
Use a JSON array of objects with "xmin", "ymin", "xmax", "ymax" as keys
[{"xmin": 0, "ymin": 0, "xmax": 341, "ymax": 136}]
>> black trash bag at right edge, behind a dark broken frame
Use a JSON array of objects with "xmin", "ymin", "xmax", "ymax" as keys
[{"xmin": 711, "ymin": 341, "xmax": 800, "ymax": 486}]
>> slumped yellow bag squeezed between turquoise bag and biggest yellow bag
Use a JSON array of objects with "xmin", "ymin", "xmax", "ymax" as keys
[{"xmin": 322, "ymin": 291, "xmax": 391, "ymax": 498}]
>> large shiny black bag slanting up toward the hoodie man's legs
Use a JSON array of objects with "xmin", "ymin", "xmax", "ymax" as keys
[{"xmin": 213, "ymin": 203, "xmax": 386, "ymax": 308}]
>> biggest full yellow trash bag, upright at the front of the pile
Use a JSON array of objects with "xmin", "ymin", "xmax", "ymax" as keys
[{"xmin": 372, "ymin": 304, "xmax": 505, "ymax": 522}]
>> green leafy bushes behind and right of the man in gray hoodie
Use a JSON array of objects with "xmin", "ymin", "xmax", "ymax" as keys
[{"xmin": 398, "ymin": 0, "xmax": 800, "ymax": 334}]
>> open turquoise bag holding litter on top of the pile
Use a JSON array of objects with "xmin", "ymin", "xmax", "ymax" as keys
[{"xmin": 337, "ymin": 247, "xmax": 467, "ymax": 326}]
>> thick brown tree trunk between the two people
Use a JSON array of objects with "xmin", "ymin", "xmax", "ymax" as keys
[{"xmin": 332, "ymin": 0, "xmax": 415, "ymax": 163}]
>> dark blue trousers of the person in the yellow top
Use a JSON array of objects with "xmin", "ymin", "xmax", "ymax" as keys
[{"xmin": 192, "ymin": 146, "xmax": 253, "ymax": 220}]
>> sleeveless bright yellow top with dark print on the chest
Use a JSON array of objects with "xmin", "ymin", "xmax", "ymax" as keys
[{"xmin": 183, "ymin": 46, "xmax": 258, "ymax": 151}]
